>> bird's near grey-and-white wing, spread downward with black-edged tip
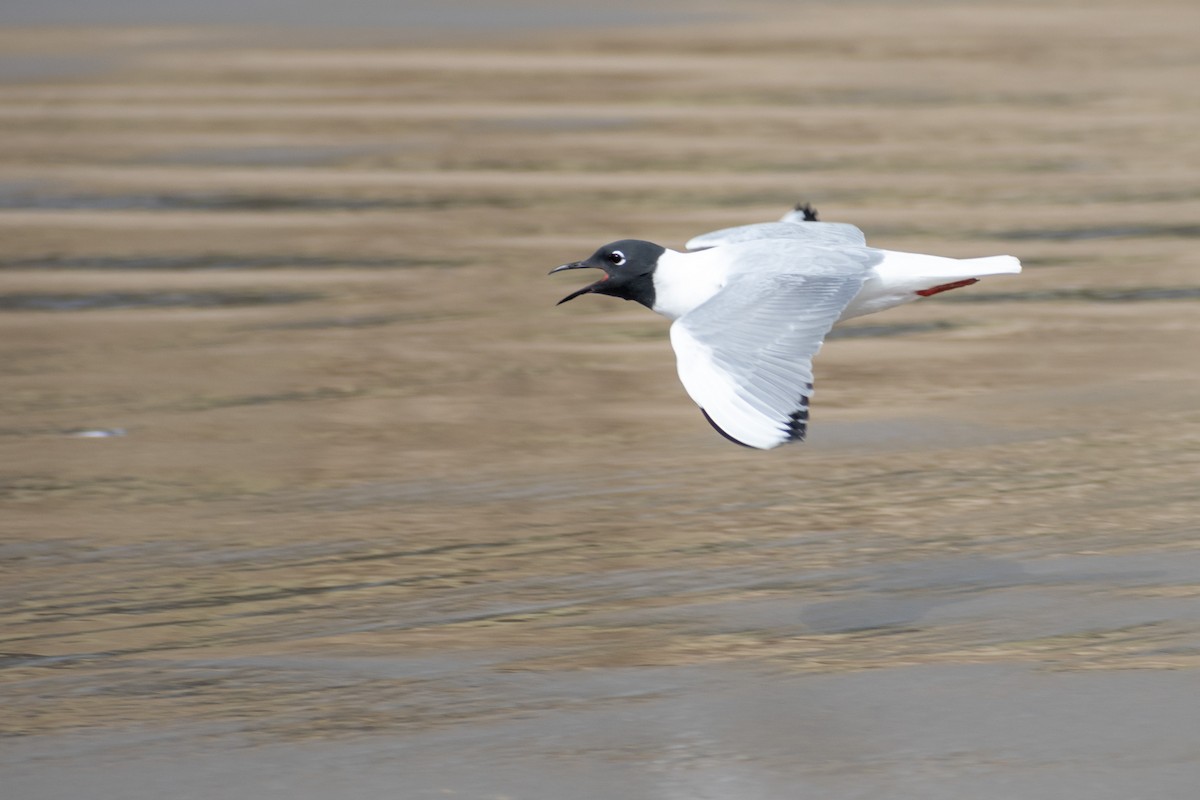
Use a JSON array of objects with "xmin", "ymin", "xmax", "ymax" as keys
[{"xmin": 671, "ymin": 243, "xmax": 876, "ymax": 450}]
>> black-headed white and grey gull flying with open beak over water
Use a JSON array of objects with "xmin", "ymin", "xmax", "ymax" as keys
[{"xmin": 550, "ymin": 205, "xmax": 1021, "ymax": 450}]
